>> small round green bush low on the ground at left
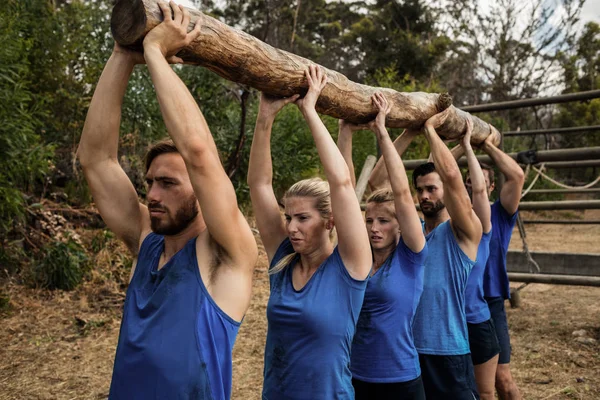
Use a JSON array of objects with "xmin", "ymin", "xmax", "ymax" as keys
[{"xmin": 33, "ymin": 237, "xmax": 88, "ymax": 290}]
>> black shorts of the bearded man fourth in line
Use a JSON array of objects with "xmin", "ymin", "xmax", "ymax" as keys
[{"xmin": 419, "ymin": 354, "xmax": 479, "ymax": 400}]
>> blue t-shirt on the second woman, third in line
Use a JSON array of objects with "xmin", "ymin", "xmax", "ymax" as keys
[{"xmin": 350, "ymin": 239, "xmax": 427, "ymax": 383}]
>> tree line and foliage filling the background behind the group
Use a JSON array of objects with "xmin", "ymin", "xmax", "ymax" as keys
[{"xmin": 0, "ymin": 0, "xmax": 600, "ymax": 287}]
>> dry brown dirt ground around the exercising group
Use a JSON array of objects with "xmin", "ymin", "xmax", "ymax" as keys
[{"xmin": 0, "ymin": 211, "xmax": 600, "ymax": 400}]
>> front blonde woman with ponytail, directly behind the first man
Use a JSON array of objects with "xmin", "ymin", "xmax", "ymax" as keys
[{"xmin": 248, "ymin": 66, "xmax": 371, "ymax": 400}]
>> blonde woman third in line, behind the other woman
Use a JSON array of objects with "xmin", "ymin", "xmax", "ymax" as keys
[{"xmin": 338, "ymin": 93, "xmax": 427, "ymax": 400}]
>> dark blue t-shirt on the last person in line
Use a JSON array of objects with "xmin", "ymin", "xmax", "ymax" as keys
[{"xmin": 483, "ymin": 200, "xmax": 518, "ymax": 299}]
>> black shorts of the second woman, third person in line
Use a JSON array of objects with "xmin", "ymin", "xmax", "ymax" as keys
[{"xmin": 352, "ymin": 377, "xmax": 425, "ymax": 400}]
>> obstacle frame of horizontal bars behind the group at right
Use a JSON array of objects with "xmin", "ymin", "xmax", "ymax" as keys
[{"xmin": 357, "ymin": 90, "xmax": 600, "ymax": 286}]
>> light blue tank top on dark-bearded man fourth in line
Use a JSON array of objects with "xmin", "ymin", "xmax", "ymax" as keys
[{"xmin": 413, "ymin": 220, "xmax": 475, "ymax": 356}]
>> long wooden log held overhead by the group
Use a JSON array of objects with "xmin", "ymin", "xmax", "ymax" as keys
[{"xmin": 111, "ymin": 0, "xmax": 500, "ymax": 144}]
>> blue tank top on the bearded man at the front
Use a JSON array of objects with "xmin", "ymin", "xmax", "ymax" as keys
[{"xmin": 109, "ymin": 233, "xmax": 240, "ymax": 400}]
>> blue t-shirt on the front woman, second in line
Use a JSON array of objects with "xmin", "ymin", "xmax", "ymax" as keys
[{"xmin": 262, "ymin": 239, "xmax": 367, "ymax": 400}]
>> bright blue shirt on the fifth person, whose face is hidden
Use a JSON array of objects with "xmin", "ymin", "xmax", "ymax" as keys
[{"xmin": 465, "ymin": 231, "xmax": 492, "ymax": 324}]
